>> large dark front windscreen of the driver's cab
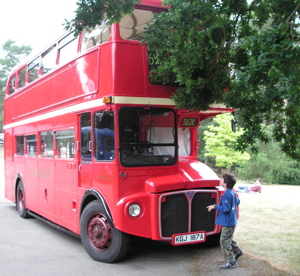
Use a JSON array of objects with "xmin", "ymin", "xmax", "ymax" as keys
[{"xmin": 119, "ymin": 107, "xmax": 177, "ymax": 166}]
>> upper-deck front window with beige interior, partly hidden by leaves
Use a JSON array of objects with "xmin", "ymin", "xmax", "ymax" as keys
[{"xmin": 120, "ymin": 9, "xmax": 154, "ymax": 40}]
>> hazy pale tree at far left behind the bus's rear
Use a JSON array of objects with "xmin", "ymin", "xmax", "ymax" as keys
[{"xmin": 0, "ymin": 40, "xmax": 32, "ymax": 129}]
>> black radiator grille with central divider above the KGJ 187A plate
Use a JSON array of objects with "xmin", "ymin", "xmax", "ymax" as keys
[{"xmin": 161, "ymin": 191, "xmax": 215, "ymax": 238}]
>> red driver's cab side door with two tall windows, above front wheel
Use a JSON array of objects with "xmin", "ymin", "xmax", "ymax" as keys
[{"xmin": 79, "ymin": 110, "xmax": 118, "ymax": 201}]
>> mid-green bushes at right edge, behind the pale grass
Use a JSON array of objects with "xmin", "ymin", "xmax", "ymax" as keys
[{"xmin": 235, "ymin": 127, "xmax": 300, "ymax": 185}]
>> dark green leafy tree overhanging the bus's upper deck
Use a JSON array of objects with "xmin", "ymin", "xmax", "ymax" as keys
[{"xmin": 68, "ymin": 0, "xmax": 300, "ymax": 160}]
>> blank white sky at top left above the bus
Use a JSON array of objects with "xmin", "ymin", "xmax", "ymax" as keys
[{"xmin": 0, "ymin": 0, "xmax": 77, "ymax": 55}]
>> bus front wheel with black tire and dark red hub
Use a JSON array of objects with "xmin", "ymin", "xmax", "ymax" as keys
[{"xmin": 80, "ymin": 200, "xmax": 130, "ymax": 263}]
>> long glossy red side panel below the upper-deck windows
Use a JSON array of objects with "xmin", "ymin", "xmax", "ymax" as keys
[{"xmin": 4, "ymin": 48, "xmax": 99, "ymax": 124}]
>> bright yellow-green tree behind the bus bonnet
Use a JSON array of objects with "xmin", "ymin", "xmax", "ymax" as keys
[{"xmin": 203, "ymin": 114, "xmax": 250, "ymax": 169}]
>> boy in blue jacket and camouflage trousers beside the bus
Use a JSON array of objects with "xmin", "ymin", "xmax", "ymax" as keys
[{"xmin": 206, "ymin": 174, "xmax": 243, "ymax": 269}]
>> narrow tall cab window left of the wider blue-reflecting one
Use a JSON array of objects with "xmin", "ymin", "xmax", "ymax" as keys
[{"xmin": 80, "ymin": 113, "xmax": 92, "ymax": 160}]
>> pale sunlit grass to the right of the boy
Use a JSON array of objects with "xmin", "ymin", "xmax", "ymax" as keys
[{"xmin": 235, "ymin": 184, "xmax": 300, "ymax": 275}]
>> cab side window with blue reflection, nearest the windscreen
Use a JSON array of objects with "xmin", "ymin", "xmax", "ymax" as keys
[{"xmin": 94, "ymin": 111, "xmax": 115, "ymax": 160}]
